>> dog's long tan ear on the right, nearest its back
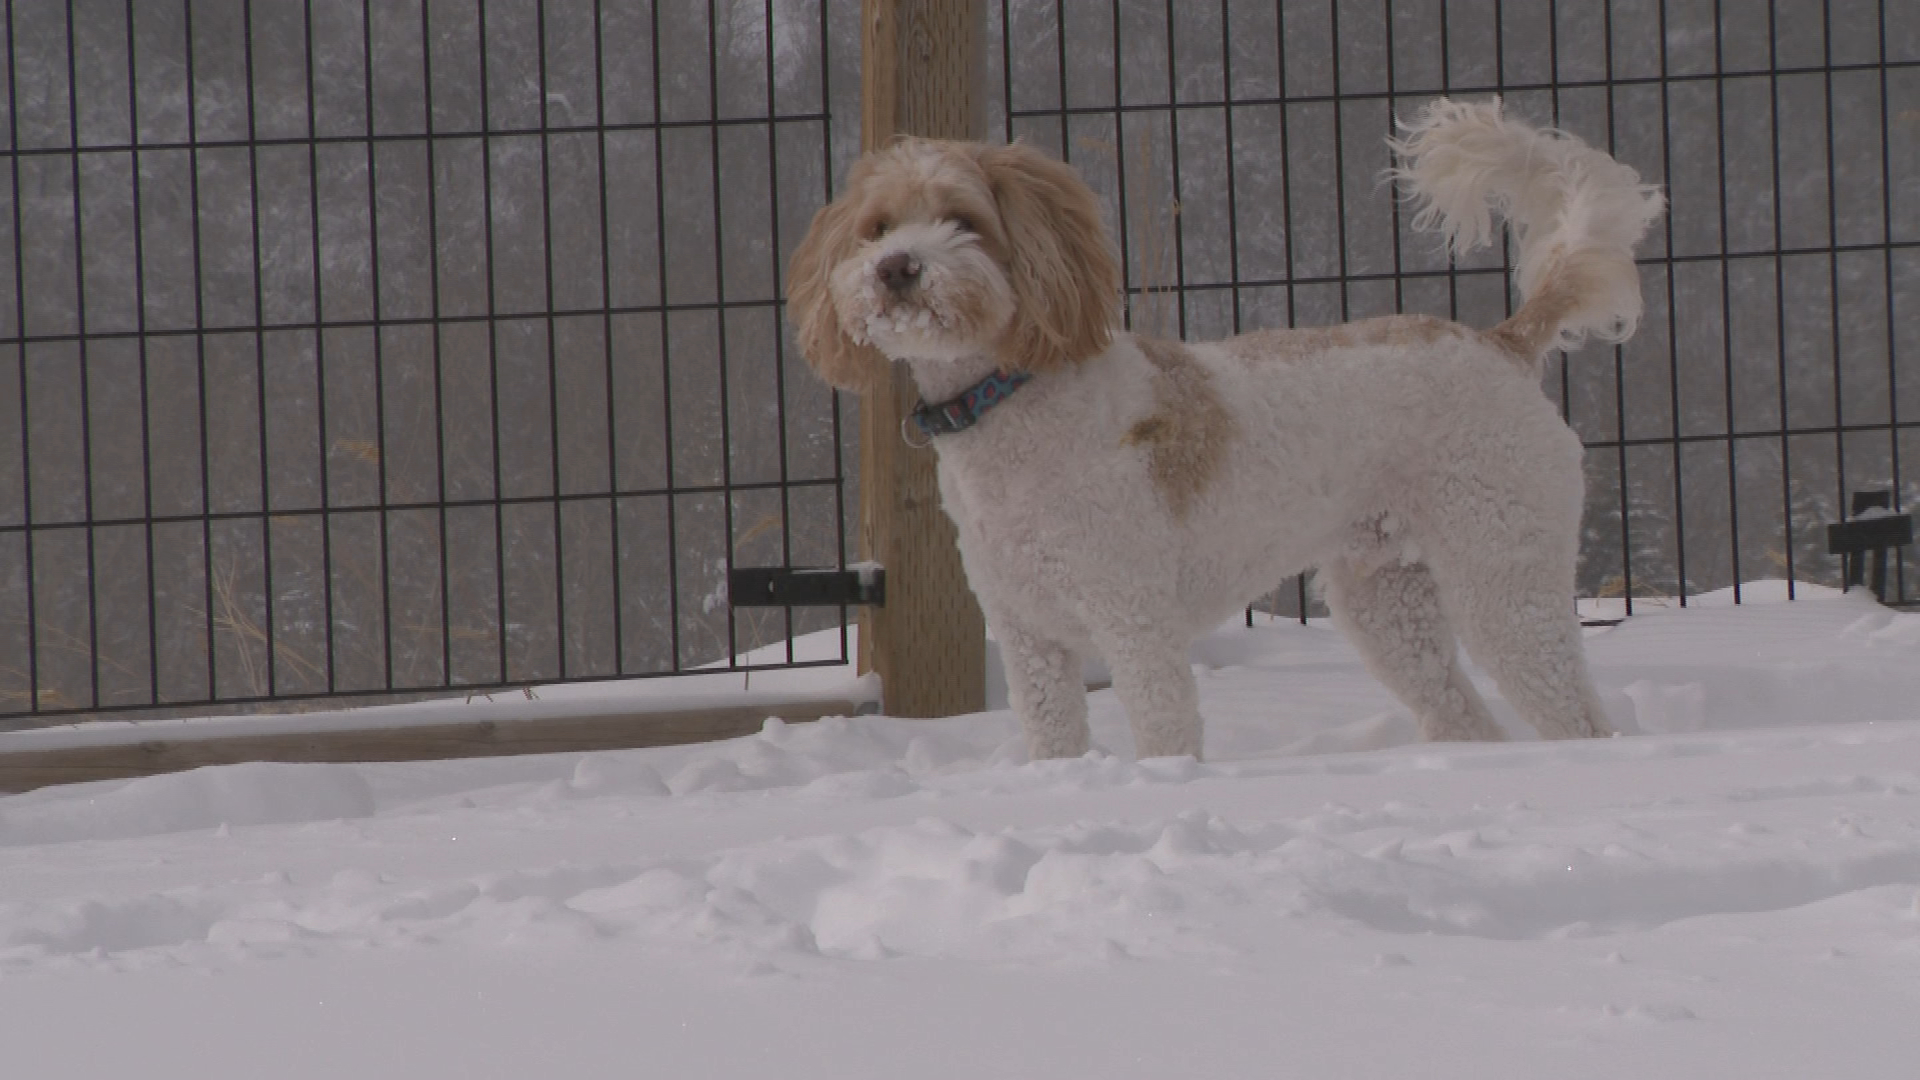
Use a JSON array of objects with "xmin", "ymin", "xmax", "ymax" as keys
[{"xmin": 977, "ymin": 142, "xmax": 1119, "ymax": 371}]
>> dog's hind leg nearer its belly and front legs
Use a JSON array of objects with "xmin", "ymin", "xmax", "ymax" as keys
[{"xmin": 1321, "ymin": 559, "xmax": 1505, "ymax": 740}]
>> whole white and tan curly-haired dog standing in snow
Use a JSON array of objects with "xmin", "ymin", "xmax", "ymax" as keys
[{"xmin": 789, "ymin": 100, "xmax": 1663, "ymax": 757}]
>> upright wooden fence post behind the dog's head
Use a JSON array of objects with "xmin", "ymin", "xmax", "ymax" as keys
[{"xmin": 860, "ymin": 0, "xmax": 987, "ymax": 717}]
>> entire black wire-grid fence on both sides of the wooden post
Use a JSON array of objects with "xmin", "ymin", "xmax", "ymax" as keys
[{"xmin": 0, "ymin": 0, "xmax": 1920, "ymax": 726}]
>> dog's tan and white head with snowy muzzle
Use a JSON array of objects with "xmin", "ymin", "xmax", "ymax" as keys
[{"xmin": 787, "ymin": 138, "xmax": 1119, "ymax": 392}]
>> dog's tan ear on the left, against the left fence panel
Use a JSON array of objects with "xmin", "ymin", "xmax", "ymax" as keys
[{"xmin": 787, "ymin": 171, "xmax": 887, "ymax": 394}]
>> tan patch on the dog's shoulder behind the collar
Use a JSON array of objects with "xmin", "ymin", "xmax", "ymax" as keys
[{"xmin": 1121, "ymin": 336, "xmax": 1236, "ymax": 519}]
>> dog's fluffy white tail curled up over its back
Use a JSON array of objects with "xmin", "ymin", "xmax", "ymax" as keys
[{"xmin": 1390, "ymin": 98, "xmax": 1667, "ymax": 361}]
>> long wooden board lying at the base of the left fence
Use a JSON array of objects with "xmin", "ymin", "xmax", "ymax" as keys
[{"xmin": 0, "ymin": 700, "xmax": 872, "ymax": 792}]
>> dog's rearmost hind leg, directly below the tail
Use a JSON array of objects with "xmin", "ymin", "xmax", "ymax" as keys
[{"xmin": 1438, "ymin": 546, "xmax": 1613, "ymax": 738}]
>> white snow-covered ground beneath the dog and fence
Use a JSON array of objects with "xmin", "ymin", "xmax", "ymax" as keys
[{"xmin": 0, "ymin": 586, "xmax": 1920, "ymax": 1080}]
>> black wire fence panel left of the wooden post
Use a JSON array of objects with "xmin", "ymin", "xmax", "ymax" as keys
[{"xmin": 0, "ymin": 0, "xmax": 845, "ymax": 723}]
